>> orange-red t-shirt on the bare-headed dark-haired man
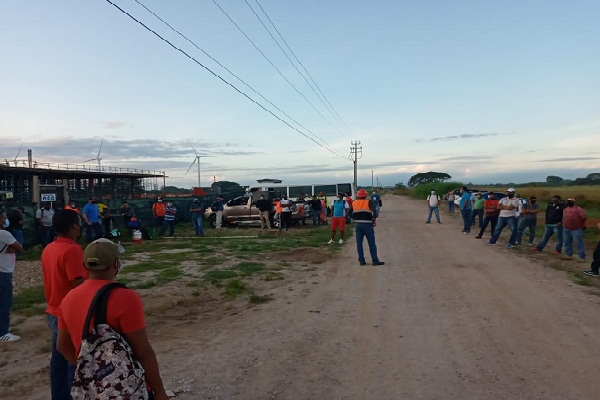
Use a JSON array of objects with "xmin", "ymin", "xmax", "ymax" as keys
[{"xmin": 42, "ymin": 236, "xmax": 89, "ymax": 316}]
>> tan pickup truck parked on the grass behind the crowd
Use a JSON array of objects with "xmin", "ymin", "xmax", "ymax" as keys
[{"xmin": 204, "ymin": 192, "xmax": 311, "ymax": 228}]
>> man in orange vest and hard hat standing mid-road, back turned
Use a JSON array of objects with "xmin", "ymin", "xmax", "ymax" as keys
[{"xmin": 351, "ymin": 189, "xmax": 385, "ymax": 265}]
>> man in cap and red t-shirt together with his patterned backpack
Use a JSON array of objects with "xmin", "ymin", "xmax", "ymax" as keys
[{"xmin": 57, "ymin": 238, "xmax": 168, "ymax": 400}]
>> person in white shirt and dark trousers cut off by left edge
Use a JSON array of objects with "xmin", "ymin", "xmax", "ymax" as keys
[{"xmin": 0, "ymin": 212, "xmax": 23, "ymax": 343}]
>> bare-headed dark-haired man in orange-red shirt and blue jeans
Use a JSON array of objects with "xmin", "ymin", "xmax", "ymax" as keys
[{"xmin": 42, "ymin": 210, "xmax": 88, "ymax": 400}]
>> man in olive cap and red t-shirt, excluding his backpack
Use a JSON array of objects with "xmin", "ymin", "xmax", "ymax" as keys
[{"xmin": 57, "ymin": 239, "xmax": 168, "ymax": 400}]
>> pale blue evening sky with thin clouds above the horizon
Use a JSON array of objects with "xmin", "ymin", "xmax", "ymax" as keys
[{"xmin": 0, "ymin": 0, "xmax": 600, "ymax": 188}]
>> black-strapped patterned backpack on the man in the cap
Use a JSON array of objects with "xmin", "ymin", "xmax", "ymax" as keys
[{"xmin": 71, "ymin": 282, "xmax": 148, "ymax": 400}]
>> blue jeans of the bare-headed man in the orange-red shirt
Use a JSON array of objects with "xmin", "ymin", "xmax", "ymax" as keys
[{"xmin": 46, "ymin": 314, "xmax": 75, "ymax": 400}]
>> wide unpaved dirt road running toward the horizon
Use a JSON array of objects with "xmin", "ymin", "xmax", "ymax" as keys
[{"xmin": 1, "ymin": 196, "xmax": 600, "ymax": 400}]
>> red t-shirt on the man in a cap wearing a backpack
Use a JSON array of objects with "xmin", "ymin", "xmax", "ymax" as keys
[{"xmin": 58, "ymin": 279, "xmax": 146, "ymax": 354}]
